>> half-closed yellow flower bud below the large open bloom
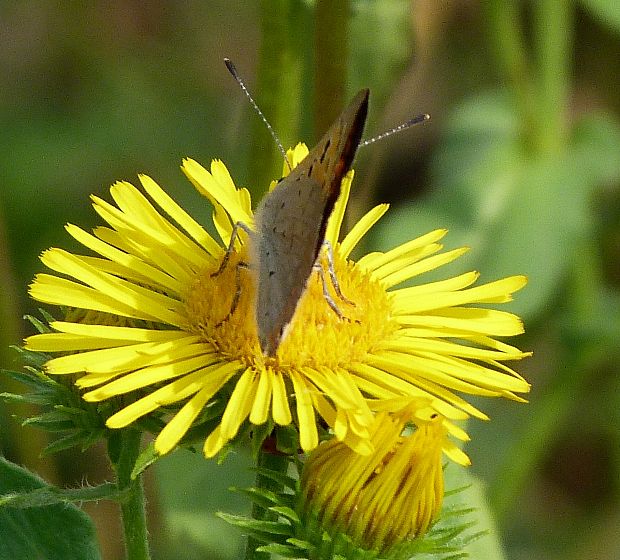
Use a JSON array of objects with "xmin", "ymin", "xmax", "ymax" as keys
[{"xmin": 301, "ymin": 401, "xmax": 460, "ymax": 551}]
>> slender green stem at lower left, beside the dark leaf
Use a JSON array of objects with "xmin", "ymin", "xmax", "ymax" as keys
[{"xmin": 114, "ymin": 429, "xmax": 151, "ymax": 560}]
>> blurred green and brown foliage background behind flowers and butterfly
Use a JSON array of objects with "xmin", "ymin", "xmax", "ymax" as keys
[{"xmin": 0, "ymin": 0, "xmax": 620, "ymax": 560}]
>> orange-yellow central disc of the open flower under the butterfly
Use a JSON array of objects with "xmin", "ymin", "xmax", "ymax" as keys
[{"xmin": 185, "ymin": 250, "xmax": 397, "ymax": 369}]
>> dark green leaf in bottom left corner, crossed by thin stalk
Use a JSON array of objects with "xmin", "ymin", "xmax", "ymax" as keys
[{"xmin": 0, "ymin": 458, "xmax": 101, "ymax": 560}]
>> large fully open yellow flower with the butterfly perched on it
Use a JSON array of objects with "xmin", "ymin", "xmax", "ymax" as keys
[{"xmin": 26, "ymin": 145, "xmax": 529, "ymax": 457}]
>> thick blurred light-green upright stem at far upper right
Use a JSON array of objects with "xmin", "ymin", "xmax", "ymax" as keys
[{"xmin": 532, "ymin": 0, "xmax": 572, "ymax": 153}]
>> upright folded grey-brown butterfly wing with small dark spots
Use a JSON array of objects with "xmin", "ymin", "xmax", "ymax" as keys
[{"xmin": 252, "ymin": 90, "xmax": 369, "ymax": 356}]
